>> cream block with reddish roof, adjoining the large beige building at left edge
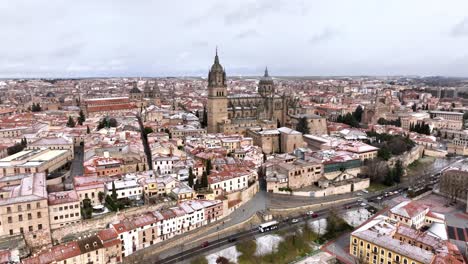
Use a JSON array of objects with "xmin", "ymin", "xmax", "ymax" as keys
[{"xmin": 48, "ymin": 190, "xmax": 81, "ymax": 229}]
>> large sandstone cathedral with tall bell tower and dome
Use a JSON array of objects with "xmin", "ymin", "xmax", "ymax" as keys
[{"xmin": 207, "ymin": 51, "xmax": 301, "ymax": 134}]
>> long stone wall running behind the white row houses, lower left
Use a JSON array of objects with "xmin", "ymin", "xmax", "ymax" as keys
[{"xmin": 52, "ymin": 202, "xmax": 176, "ymax": 244}]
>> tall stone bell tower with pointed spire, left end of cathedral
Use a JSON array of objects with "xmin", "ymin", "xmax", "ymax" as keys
[{"xmin": 207, "ymin": 49, "xmax": 228, "ymax": 133}]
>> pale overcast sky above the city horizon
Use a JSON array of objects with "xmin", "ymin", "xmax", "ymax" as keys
[{"xmin": 0, "ymin": 0, "xmax": 468, "ymax": 78}]
